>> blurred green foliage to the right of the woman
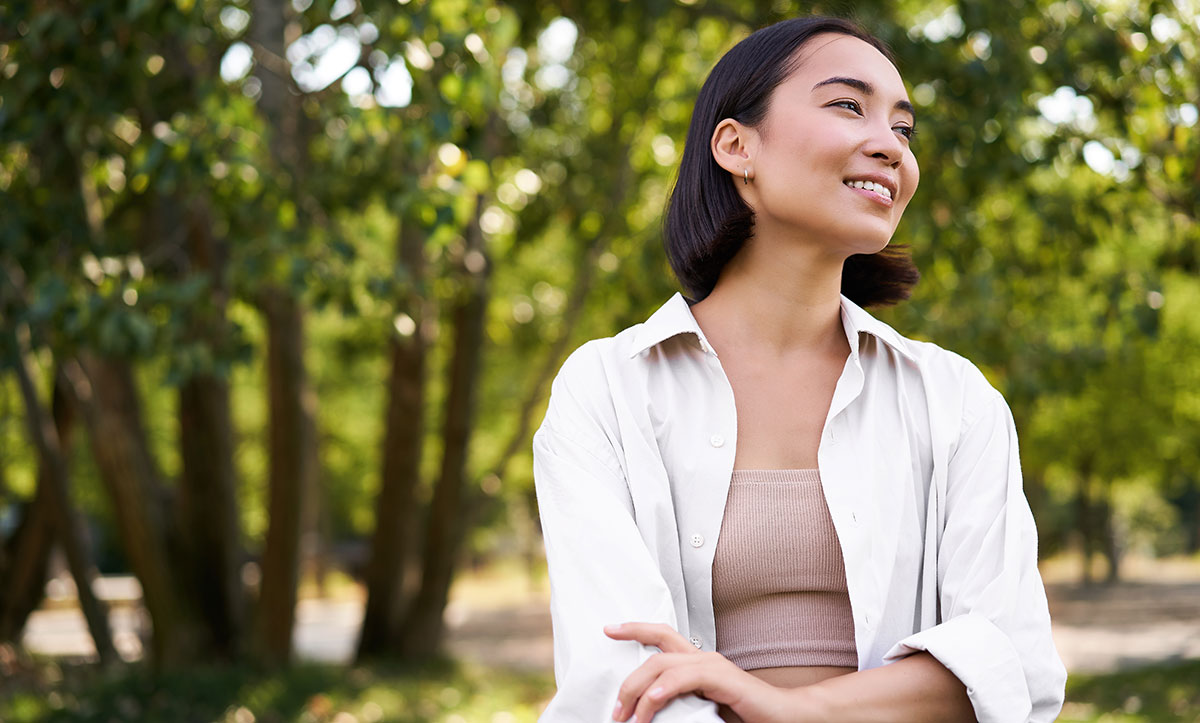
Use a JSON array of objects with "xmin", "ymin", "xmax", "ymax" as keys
[{"xmin": 873, "ymin": 1, "xmax": 1200, "ymax": 559}]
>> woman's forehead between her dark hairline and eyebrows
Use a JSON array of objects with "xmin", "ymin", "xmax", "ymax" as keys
[{"xmin": 787, "ymin": 32, "xmax": 907, "ymax": 98}]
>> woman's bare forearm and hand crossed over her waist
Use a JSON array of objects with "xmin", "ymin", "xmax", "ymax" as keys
[{"xmin": 605, "ymin": 623, "xmax": 974, "ymax": 723}]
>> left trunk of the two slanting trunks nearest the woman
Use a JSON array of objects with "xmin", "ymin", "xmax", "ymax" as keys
[{"xmin": 358, "ymin": 217, "xmax": 427, "ymax": 659}]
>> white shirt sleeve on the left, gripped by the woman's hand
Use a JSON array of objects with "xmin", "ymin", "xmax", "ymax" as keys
[{"xmin": 533, "ymin": 377, "xmax": 720, "ymax": 723}]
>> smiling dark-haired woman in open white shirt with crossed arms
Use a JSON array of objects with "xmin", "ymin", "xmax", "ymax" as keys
[{"xmin": 534, "ymin": 12, "xmax": 1066, "ymax": 723}]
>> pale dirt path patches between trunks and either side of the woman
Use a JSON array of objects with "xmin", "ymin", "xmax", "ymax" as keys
[{"xmin": 24, "ymin": 571, "xmax": 1200, "ymax": 674}]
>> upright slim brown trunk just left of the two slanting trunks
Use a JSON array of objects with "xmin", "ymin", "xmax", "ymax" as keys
[{"xmin": 257, "ymin": 289, "xmax": 316, "ymax": 664}]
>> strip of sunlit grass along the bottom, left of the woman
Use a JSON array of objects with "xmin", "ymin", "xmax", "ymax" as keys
[{"xmin": 0, "ymin": 662, "xmax": 553, "ymax": 723}]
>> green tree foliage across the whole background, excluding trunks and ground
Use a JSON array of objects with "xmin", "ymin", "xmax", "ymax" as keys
[{"xmin": 0, "ymin": 0, "xmax": 1200, "ymax": 648}]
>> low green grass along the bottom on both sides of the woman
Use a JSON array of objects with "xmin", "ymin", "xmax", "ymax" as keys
[{"xmin": 0, "ymin": 661, "xmax": 1200, "ymax": 723}]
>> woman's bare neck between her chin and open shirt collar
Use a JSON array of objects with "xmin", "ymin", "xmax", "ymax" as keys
[{"xmin": 692, "ymin": 228, "xmax": 848, "ymax": 357}]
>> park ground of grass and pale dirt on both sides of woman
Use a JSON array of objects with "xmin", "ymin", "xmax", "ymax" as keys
[{"xmin": 0, "ymin": 558, "xmax": 1200, "ymax": 723}]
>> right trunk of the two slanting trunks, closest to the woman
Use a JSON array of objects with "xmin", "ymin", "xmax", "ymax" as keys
[{"xmin": 401, "ymin": 197, "xmax": 490, "ymax": 659}]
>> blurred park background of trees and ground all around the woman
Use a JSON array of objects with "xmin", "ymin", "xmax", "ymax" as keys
[{"xmin": 0, "ymin": 0, "xmax": 1200, "ymax": 723}]
